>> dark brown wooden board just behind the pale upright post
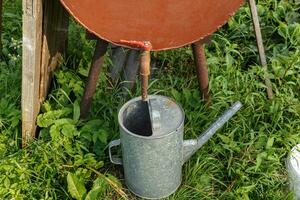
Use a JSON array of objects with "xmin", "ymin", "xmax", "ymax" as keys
[{"xmin": 39, "ymin": 0, "xmax": 69, "ymax": 102}]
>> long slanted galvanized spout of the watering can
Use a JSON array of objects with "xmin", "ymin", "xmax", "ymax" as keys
[{"xmin": 183, "ymin": 101, "xmax": 242, "ymax": 163}]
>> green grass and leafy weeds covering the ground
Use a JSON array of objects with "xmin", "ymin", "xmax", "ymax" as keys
[{"xmin": 0, "ymin": 0, "xmax": 300, "ymax": 200}]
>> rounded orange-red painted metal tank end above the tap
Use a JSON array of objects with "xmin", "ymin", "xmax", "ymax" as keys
[{"xmin": 61, "ymin": 0, "xmax": 244, "ymax": 51}]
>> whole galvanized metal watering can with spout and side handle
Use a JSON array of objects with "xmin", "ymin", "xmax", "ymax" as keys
[{"xmin": 109, "ymin": 95, "xmax": 242, "ymax": 199}]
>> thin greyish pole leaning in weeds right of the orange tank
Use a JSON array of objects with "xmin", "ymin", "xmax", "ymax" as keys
[{"xmin": 249, "ymin": 0, "xmax": 273, "ymax": 99}]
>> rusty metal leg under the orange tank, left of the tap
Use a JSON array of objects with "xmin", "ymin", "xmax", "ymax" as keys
[{"xmin": 80, "ymin": 39, "xmax": 108, "ymax": 118}]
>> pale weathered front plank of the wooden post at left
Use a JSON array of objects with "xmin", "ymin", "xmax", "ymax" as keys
[{"xmin": 22, "ymin": 0, "xmax": 43, "ymax": 146}]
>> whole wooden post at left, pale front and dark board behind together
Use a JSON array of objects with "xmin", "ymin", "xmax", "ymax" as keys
[{"xmin": 22, "ymin": 0, "xmax": 68, "ymax": 146}]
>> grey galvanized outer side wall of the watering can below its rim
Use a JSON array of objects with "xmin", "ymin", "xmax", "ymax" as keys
[{"xmin": 111, "ymin": 126, "xmax": 183, "ymax": 199}]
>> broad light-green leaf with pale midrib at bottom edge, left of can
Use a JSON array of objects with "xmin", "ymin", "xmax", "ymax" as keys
[{"xmin": 67, "ymin": 173, "xmax": 86, "ymax": 200}]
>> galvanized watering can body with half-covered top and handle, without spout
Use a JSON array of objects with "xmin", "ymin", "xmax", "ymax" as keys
[{"xmin": 109, "ymin": 95, "xmax": 184, "ymax": 199}]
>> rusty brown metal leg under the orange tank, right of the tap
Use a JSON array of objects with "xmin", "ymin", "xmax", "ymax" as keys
[{"xmin": 192, "ymin": 41, "xmax": 210, "ymax": 103}]
